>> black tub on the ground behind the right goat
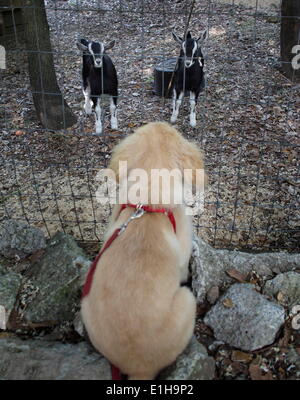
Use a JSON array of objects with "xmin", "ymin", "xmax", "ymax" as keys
[{"xmin": 153, "ymin": 57, "xmax": 177, "ymax": 97}]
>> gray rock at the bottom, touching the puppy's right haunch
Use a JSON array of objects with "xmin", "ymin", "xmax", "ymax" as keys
[{"xmin": 158, "ymin": 337, "xmax": 215, "ymax": 380}]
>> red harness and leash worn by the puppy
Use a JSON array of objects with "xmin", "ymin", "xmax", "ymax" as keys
[{"xmin": 81, "ymin": 204, "xmax": 176, "ymax": 380}]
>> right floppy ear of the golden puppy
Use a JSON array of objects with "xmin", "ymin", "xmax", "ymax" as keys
[{"xmin": 181, "ymin": 139, "xmax": 207, "ymax": 188}]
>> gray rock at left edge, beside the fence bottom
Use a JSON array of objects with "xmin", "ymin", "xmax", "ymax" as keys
[{"xmin": 0, "ymin": 219, "xmax": 46, "ymax": 259}]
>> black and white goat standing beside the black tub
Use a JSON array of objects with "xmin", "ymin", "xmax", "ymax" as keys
[{"xmin": 171, "ymin": 30, "xmax": 207, "ymax": 128}]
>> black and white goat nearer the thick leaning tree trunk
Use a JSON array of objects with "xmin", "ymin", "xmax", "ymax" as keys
[{"xmin": 77, "ymin": 39, "xmax": 118, "ymax": 135}]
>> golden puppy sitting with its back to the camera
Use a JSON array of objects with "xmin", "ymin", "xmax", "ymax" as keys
[{"xmin": 81, "ymin": 122, "xmax": 203, "ymax": 379}]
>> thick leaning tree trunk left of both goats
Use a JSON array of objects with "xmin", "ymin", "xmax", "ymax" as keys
[{"xmin": 22, "ymin": 0, "xmax": 76, "ymax": 130}]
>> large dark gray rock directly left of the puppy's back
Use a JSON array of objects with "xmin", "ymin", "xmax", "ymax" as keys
[{"xmin": 23, "ymin": 233, "xmax": 90, "ymax": 323}]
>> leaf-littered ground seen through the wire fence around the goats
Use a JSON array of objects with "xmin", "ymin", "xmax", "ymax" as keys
[{"xmin": 0, "ymin": 0, "xmax": 300, "ymax": 251}]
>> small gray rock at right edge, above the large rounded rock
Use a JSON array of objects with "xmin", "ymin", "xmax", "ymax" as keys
[{"xmin": 263, "ymin": 271, "xmax": 300, "ymax": 308}]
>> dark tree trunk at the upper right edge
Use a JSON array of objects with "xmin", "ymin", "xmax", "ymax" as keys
[{"xmin": 280, "ymin": 0, "xmax": 300, "ymax": 82}]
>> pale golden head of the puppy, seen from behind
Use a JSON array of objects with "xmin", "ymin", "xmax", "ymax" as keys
[{"xmin": 109, "ymin": 122, "xmax": 207, "ymax": 204}]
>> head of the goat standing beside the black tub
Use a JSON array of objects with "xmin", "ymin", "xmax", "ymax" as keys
[{"xmin": 172, "ymin": 31, "xmax": 207, "ymax": 68}]
